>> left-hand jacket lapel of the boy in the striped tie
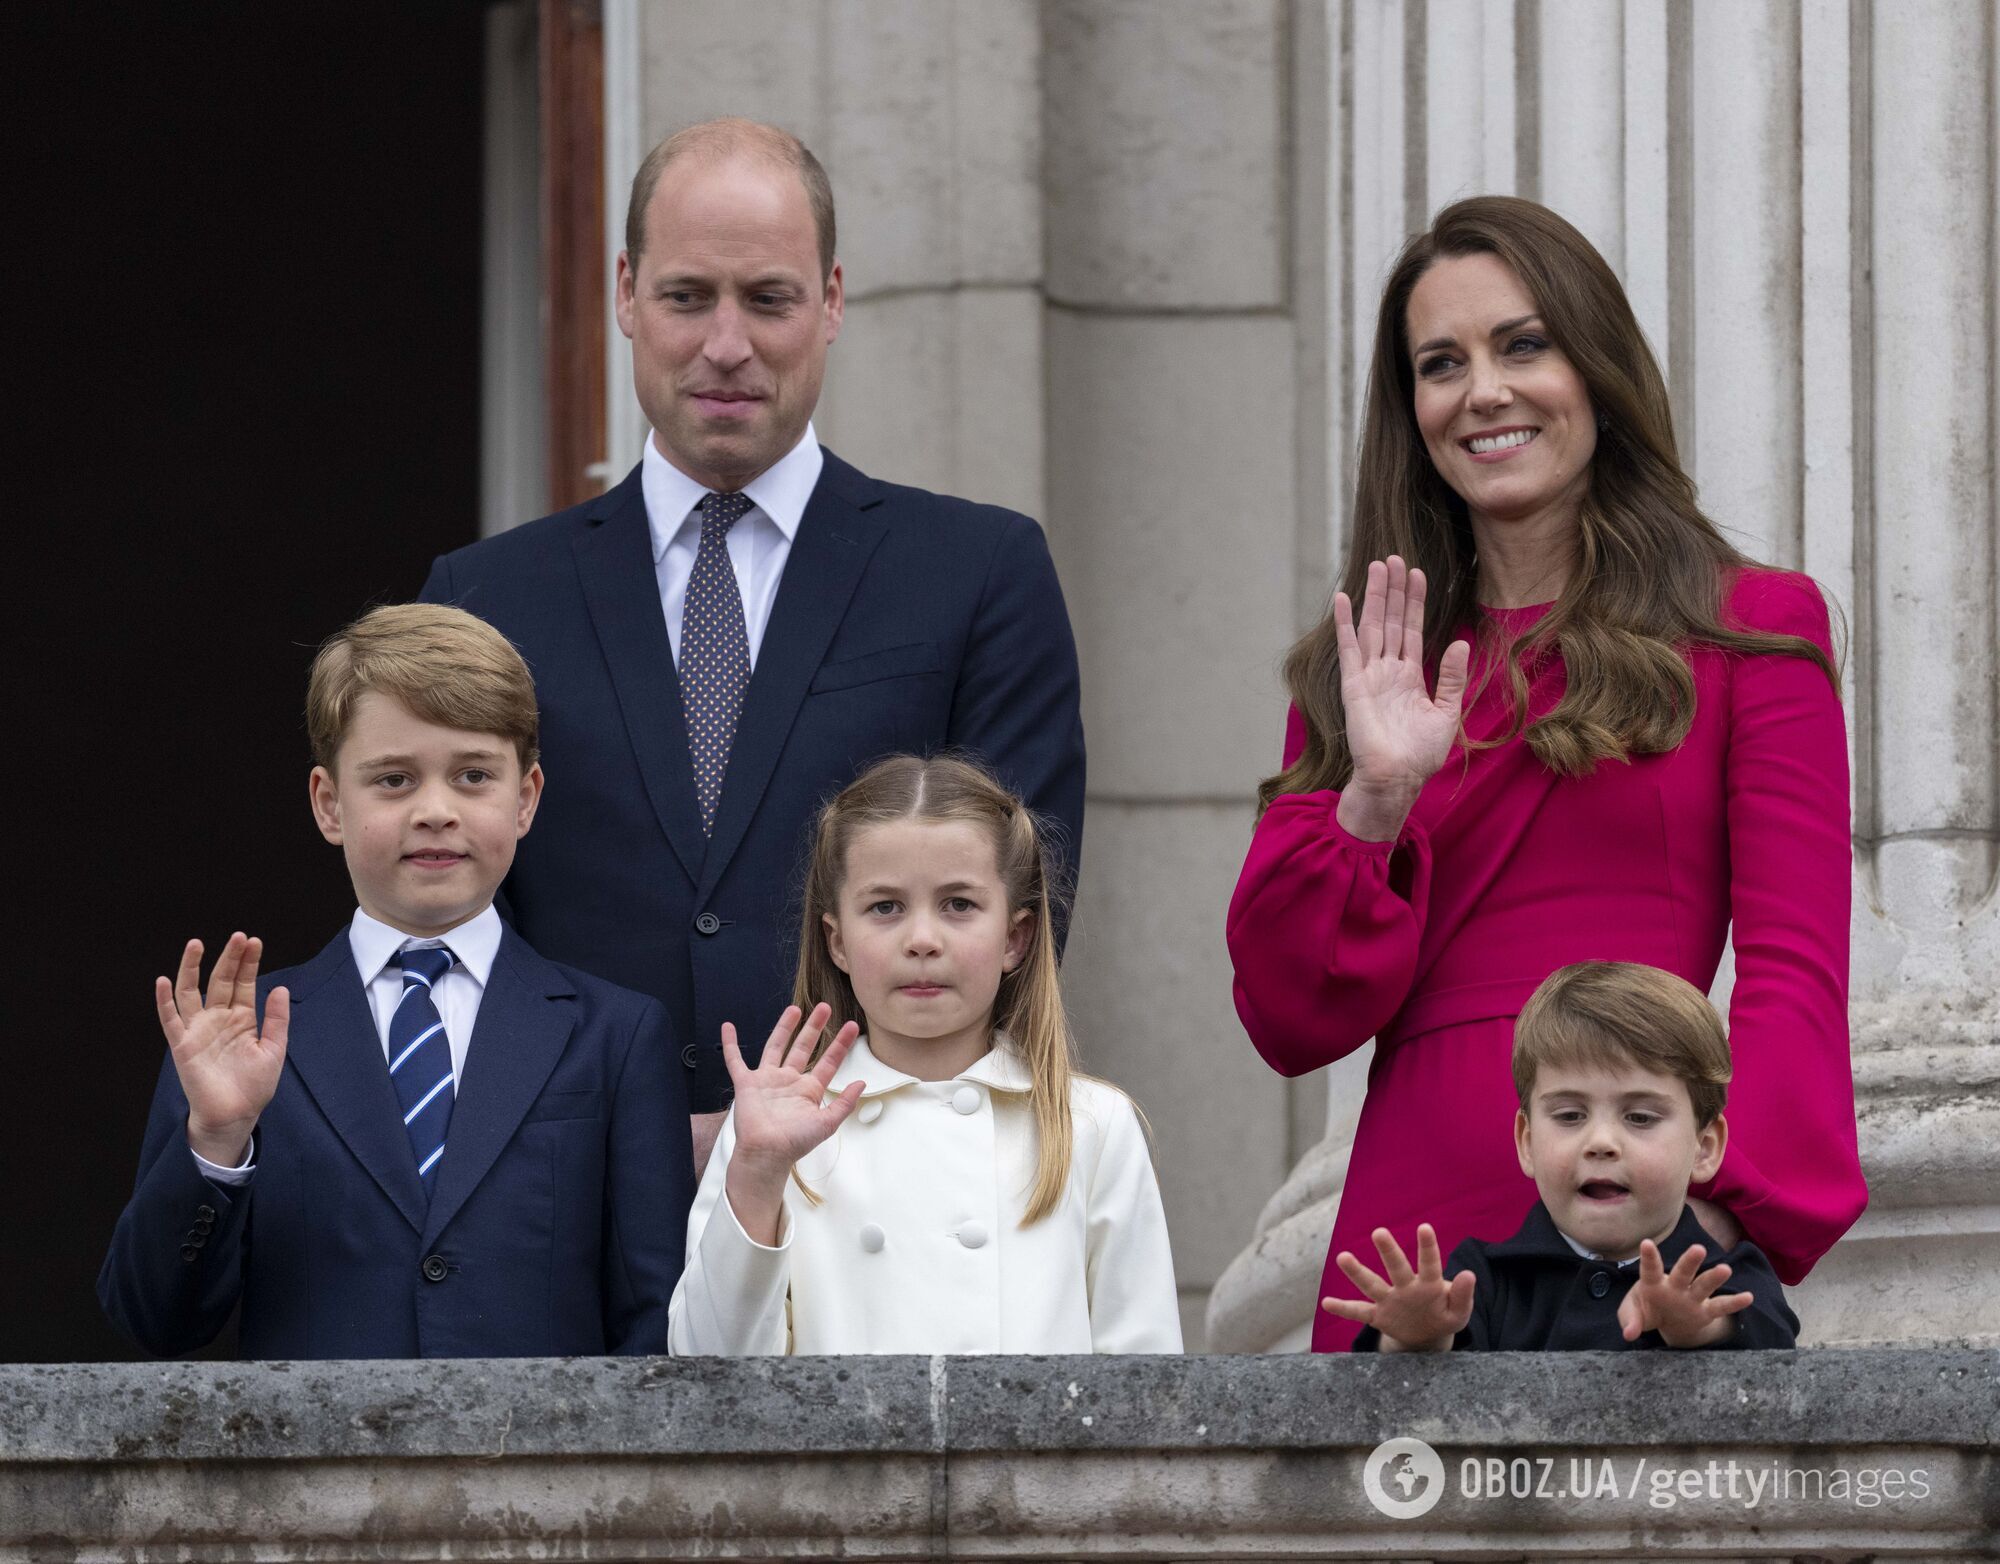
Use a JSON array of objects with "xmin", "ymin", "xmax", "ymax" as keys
[{"xmin": 284, "ymin": 930, "xmax": 424, "ymax": 1230}]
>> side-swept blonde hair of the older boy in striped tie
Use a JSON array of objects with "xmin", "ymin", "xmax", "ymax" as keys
[{"xmin": 306, "ymin": 602, "xmax": 542, "ymax": 774}]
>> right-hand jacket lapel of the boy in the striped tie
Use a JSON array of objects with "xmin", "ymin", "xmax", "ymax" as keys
[{"xmin": 422, "ymin": 930, "xmax": 576, "ymax": 1244}]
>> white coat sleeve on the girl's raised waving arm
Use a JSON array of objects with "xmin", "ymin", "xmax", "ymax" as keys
[{"xmin": 666, "ymin": 1110, "xmax": 792, "ymax": 1358}]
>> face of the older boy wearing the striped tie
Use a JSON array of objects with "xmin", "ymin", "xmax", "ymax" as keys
[{"xmin": 310, "ymin": 690, "xmax": 542, "ymax": 938}]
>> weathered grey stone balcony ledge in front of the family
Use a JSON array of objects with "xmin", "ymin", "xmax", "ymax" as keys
[{"xmin": 0, "ymin": 1350, "xmax": 2000, "ymax": 1562}]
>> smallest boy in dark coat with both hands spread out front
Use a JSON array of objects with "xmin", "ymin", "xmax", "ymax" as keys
[{"xmin": 1320, "ymin": 962, "xmax": 1798, "ymax": 1352}]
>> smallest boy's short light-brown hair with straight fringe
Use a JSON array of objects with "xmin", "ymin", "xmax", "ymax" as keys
[{"xmin": 1514, "ymin": 962, "xmax": 1730, "ymax": 1128}]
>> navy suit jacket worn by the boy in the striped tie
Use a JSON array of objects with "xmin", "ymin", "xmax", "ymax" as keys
[{"xmin": 98, "ymin": 930, "xmax": 694, "ymax": 1358}]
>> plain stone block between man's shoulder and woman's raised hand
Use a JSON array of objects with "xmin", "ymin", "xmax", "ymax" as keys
[{"xmin": 1048, "ymin": 310, "xmax": 1298, "ymax": 796}]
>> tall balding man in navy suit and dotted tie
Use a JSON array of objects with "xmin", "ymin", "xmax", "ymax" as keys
[{"xmin": 424, "ymin": 120, "xmax": 1084, "ymax": 1166}]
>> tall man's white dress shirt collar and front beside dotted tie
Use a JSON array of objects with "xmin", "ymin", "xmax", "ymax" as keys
[{"xmin": 638, "ymin": 422, "xmax": 826, "ymax": 668}]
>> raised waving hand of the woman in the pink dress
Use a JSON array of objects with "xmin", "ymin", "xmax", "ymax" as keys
[{"xmin": 1334, "ymin": 554, "xmax": 1472, "ymax": 842}]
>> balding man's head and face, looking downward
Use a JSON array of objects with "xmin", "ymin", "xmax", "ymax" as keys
[{"xmin": 616, "ymin": 152, "xmax": 842, "ymax": 490}]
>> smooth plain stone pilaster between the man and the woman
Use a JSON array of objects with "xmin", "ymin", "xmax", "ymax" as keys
[{"xmin": 1042, "ymin": 0, "xmax": 1300, "ymax": 1346}]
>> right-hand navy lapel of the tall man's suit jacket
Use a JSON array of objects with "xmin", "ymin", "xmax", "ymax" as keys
[{"xmin": 704, "ymin": 452, "xmax": 886, "ymax": 900}]
